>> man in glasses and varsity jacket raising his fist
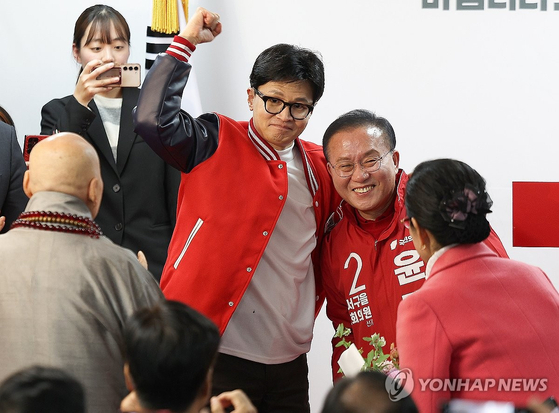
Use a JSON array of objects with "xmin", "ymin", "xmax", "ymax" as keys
[{"xmin": 134, "ymin": 8, "xmax": 339, "ymax": 412}]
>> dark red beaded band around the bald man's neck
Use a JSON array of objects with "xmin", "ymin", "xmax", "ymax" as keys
[{"xmin": 11, "ymin": 211, "xmax": 103, "ymax": 238}]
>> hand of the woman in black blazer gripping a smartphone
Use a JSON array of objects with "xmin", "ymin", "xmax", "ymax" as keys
[{"xmin": 74, "ymin": 60, "xmax": 120, "ymax": 107}]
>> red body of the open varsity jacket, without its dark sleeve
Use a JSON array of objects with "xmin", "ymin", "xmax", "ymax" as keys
[{"xmin": 161, "ymin": 115, "xmax": 339, "ymax": 333}]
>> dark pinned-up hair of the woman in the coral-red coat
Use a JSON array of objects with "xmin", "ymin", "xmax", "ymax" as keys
[{"xmin": 406, "ymin": 159, "xmax": 492, "ymax": 247}]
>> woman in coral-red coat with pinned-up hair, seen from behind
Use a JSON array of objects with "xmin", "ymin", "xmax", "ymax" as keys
[{"xmin": 397, "ymin": 159, "xmax": 559, "ymax": 412}]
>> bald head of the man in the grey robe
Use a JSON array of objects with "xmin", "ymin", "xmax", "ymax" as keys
[{"xmin": 24, "ymin": 132, "xmax": 103, "ymax": 217}]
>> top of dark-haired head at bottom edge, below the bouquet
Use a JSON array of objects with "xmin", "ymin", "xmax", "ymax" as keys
[{"xmin": 322, "ymin": 371, "xmax": 418, "ymax": 413}]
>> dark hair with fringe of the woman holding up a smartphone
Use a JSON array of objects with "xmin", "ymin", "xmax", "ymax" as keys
[{"xmin": 73, "ymin": 4, "xmax": 130, "ymax": 51}]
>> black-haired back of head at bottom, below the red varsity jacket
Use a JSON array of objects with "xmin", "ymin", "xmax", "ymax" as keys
[{"xmin": 124, "ymin": 301, "xmax": 220, "ymax": 412}]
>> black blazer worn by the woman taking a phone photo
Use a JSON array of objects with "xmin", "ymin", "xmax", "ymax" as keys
[{"xmin": 41, "ymin": 88, "xmax": 180, "ymax": 280}]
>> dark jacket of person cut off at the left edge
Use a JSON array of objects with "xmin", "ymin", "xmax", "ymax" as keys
[{"xmin": 0, "ymin": 121, "xmax": 29, "ymax": 233}]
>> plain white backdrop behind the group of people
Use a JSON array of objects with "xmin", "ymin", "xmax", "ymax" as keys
[{"xmin": 0, "ymin": 0, "xmax": 559, "ymax": 412}]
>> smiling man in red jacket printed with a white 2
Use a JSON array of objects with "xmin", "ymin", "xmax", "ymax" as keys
[{"xmin": 321, "ymin": 110, "xmax": 507, "ymax": 379}]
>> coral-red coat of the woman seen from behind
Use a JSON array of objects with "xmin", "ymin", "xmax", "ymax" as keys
[{"xmin": 397, "ymin": 243, "xmax": 559, "ymax": 412}]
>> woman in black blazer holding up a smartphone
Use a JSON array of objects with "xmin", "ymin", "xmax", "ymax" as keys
[{"xmin": 41, "ymin": 5, "xmax": 180, "ymax": 280}]
